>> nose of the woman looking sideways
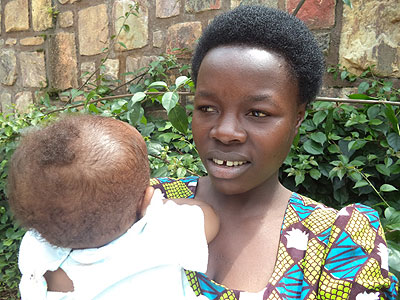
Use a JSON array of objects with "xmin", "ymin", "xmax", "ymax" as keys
[{"xmin": 210, "ymin": 115, "xmax": 247, "ymax": 144}]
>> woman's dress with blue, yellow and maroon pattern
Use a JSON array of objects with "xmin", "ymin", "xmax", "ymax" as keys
[{"xmin": 151, "ymin": 176, "xmax": 398, "ymax": 300}]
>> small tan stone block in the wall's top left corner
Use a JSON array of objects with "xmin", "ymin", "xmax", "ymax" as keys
[{"xmin": 4, "ymin": 0, "xmax": 29, "ymax": 32}]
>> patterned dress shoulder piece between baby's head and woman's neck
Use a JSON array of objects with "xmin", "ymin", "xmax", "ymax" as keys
[{"xmin": 150, "ymin": 176, "xmax": 199, "ymax": 199}]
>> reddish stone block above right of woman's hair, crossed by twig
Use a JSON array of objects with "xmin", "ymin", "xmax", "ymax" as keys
[{"xmin": 286, "ymin": 0, "xmax": 336, "ymax": 29}]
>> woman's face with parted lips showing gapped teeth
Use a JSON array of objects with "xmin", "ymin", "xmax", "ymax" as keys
[{"xmin": 192, "ymin": 46, "xmax": 305, "ymax": 195}]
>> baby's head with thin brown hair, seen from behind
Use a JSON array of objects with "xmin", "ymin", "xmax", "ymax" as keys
[{"xmin": 8, "ymin": 115, "xmax": 150, "ymax": 248}]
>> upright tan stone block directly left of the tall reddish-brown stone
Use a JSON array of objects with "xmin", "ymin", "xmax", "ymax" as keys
[{"xmin": 19, "ymin": 52, "xmax": 47, "ymax": 88}]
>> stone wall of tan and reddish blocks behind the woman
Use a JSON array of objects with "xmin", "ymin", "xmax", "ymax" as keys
[{"xmin": 0, "ymin": 0, "xmax": 400, "ymax": 111}]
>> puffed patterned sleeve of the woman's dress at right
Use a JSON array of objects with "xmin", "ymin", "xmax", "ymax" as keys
[{"xmin": 319, "ymin": 204, "xmax": 398, "ymax": 300}]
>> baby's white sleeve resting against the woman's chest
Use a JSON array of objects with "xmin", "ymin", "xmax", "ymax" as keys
[{"xmin": 145, "ymin": 199, "xmax": 208, "ymax": 272}]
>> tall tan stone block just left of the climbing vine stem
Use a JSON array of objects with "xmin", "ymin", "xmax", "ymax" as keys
[{"xmin": 78, "ymin": 4, "xmax": 109, "ymax": 55}]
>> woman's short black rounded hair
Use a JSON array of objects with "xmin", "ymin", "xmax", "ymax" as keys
[{"xmin": 192, "ymin": 5, "xmax": 325, "ymax": 103}]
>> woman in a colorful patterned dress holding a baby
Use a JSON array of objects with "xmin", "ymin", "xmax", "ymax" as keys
[{"xmin": 153, "ymin": 6, "xmax": 396, "ymax": 299}]
